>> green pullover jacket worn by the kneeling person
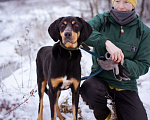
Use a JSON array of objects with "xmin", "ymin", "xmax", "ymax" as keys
[{"xmin": 85, "ymin": 12, "xmax": 150, "ymax": 92}]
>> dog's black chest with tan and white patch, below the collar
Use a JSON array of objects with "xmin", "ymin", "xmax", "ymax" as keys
[{"xmin": 49, "ymin": 45, "xmax": 81, "ymax": 90}]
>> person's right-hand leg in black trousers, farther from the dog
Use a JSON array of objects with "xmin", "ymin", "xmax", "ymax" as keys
[{"xmin": 115, "ymin": 90, "xmax": 148, "ymax": 120}]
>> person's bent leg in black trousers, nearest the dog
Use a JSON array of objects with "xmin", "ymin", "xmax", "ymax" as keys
[{"xmin": 80, "ymin": 77, "xmax": 110, "ymax": 120}]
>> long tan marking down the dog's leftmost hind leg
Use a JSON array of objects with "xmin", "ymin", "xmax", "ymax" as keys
[{"xmin": 37, "ymin": 78, "xmax": 47, "ymax": 120}]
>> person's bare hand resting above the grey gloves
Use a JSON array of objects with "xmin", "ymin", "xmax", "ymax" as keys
[{"xmin": 105, "ymin": 40, "xmax": 124, "ymax": 63}]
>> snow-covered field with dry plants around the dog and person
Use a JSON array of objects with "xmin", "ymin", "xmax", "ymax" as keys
[{"xmin": 0, "ymin": 0, "xmax": 150, "ymax": 120}]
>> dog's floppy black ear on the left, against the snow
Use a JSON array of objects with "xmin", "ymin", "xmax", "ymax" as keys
[{"xmin": 48, "ymin": 17, "xmax": 64, "ymax": 42}]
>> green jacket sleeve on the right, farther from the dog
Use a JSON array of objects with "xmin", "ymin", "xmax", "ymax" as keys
[{"xmin": 124, "ymin": 25, "xmax": 150, "ymax": 79}]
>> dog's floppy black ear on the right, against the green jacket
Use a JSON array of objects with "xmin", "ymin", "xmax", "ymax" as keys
[{"xmin": 77, "ymin": 17, "xmax": 93, "ymax": 42}]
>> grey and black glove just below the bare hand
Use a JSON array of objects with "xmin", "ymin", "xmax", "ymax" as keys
[{"xmin": 97, "ymin": 57, "xmax": 131, "ymax": 81}]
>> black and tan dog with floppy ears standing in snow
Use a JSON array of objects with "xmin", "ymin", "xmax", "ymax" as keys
[{"xmin": 36, "ymin": 16, "xmax": 92, "ymax": 120}]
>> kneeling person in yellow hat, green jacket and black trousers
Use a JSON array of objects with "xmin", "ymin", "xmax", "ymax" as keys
[{"xmin": 80, "ymin": 0, "xmax": 150, "ymax": 120}]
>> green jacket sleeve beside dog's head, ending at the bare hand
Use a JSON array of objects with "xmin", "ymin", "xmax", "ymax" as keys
[{"xmin": 85, "ymin": 14, "xmax": 108, "ymax": 48}]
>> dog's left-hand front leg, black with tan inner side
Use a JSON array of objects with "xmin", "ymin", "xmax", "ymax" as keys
[{"xmin": 49, "ymin": 89, "xmax": 57, "ymax": 120}]
